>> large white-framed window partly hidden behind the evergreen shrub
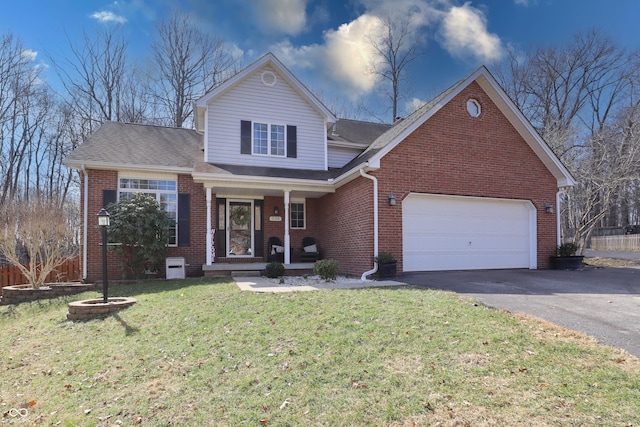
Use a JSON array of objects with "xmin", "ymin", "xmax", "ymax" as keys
[{"xmin": 118, "ymin": 178, "xmax": 178, "ymax": 246}]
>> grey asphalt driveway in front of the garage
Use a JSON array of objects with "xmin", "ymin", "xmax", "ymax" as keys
[{"xmin": 400, "ymin": 268, "xmax": 640, "ymax": 357}]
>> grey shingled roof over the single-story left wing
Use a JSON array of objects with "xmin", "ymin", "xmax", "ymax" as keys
[{"xmin": 64, "ymin": 122, "xmax": 203, "ymax": 173}]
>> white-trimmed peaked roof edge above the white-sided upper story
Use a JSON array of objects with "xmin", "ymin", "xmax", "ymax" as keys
[{"xmin": 194, "ymin": 52, "xmax": 337, "ymax": 131}]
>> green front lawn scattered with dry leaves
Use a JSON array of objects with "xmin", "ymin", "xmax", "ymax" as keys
[{"xmin": 0, "ymin": 280, "xmax": 640, "ymax": 427}]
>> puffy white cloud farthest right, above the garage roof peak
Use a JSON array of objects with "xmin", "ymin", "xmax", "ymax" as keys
[{"xmin": 442, "ymin": 3, "xmax": 502, "ymax": 61}]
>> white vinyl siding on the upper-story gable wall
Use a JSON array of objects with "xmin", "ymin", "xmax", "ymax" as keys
[{"xmin": 205, "ymin": 67, "xmax": 326, "ymax": 170}]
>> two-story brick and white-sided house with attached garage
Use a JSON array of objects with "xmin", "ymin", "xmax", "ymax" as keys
[{"xmin": 65, "ymin": 54, "xmax": 574, "ymax": 280}]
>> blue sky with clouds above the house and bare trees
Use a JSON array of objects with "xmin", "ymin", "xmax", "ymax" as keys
[{"xmin": 0, "ymin": 0, "xmax": 640, "ymax": 120}]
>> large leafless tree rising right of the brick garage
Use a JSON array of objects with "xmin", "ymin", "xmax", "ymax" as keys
[{"xmin": 497, "ymin": 30, "xmax": 638, "ymax": 250}]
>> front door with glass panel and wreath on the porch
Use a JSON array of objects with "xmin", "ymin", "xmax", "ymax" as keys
[{"xmin": 227, "ymin": 200, "xmax": 254, "ymax": 257}]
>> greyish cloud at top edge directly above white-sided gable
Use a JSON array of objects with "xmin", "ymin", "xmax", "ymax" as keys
[{"xmin": 255, "ymin": 0, "xmax": 307, "ymax": 35}]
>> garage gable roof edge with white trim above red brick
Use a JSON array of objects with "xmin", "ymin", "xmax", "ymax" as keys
[{"xmin": 341, "ymin": 66, "xmax": 575, "ymax": 187}]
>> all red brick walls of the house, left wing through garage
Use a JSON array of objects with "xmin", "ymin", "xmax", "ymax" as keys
[{"xmin": 81, "ymin": 83, "xmax": 557, "ymax": 282}]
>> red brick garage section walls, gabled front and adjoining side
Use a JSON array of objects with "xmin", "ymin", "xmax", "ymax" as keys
[{"xmin": 320, "ymin": 83, "xmax": 557, "ymax": 274}]
